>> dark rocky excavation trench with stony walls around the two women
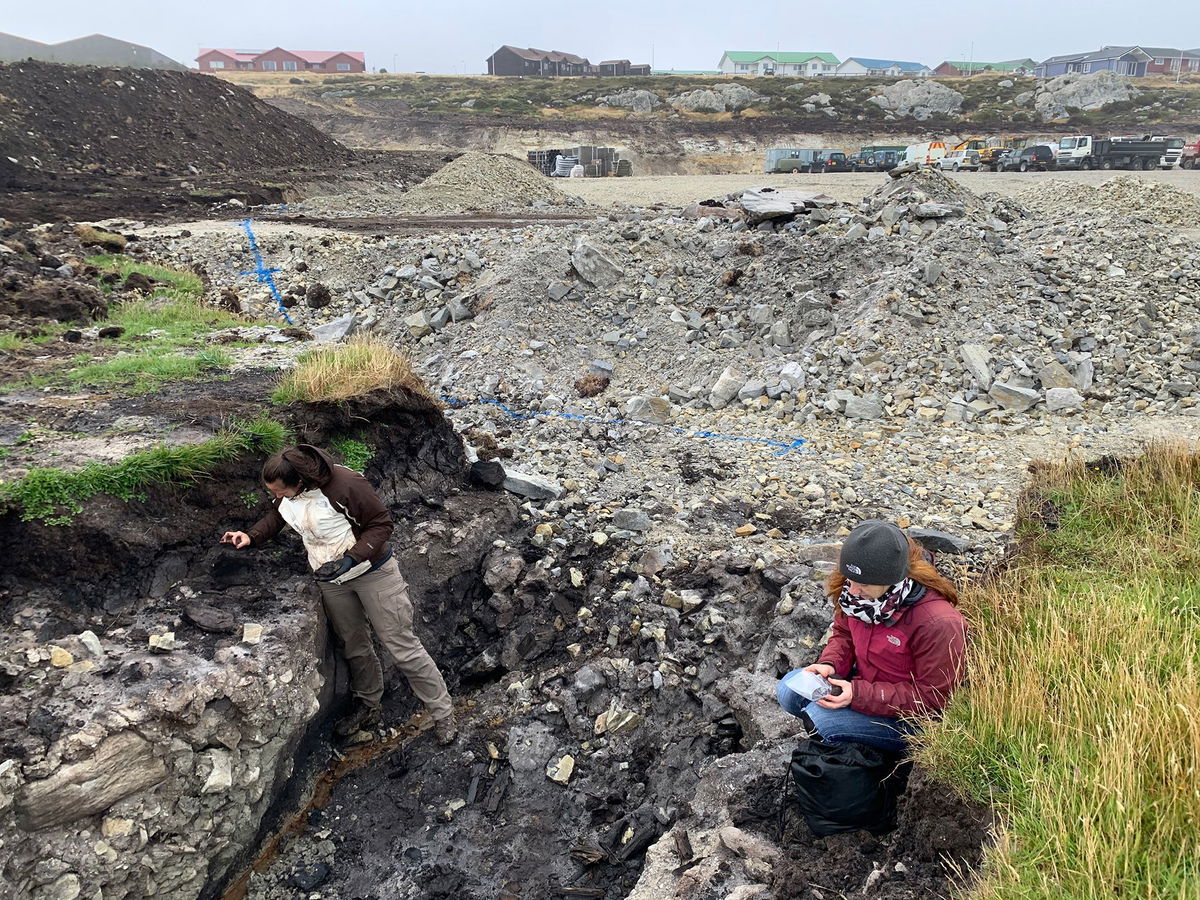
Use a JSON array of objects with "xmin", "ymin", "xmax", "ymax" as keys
[{"xmin": 0, "ymin": 385, "xmax": 985, "ymax": 900}]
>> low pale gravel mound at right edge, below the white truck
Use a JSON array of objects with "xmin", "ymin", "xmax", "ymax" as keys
[{"xmin": 1018, "ymin": 175, "xmax": 1200, "ymax": 226}]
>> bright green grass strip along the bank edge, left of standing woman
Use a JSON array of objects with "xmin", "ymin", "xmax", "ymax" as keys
[{"xmin": 0, "ymin": 419, "xmax": 288, "ymax": 526}]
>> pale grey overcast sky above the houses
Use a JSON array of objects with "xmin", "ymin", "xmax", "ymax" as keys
[{"xmin": 9, "ymin": 0, "xmax": 1200, "ymax": 74}]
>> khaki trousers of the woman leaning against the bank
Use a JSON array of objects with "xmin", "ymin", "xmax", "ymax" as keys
[{"xmin": 318, "ymin": 557, "xmax": 452, "ymax": 719}]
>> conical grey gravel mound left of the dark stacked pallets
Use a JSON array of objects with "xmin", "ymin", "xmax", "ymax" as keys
[{"xmin": 404, "ymin": 152, "xmax": 569, "ymax": 215}]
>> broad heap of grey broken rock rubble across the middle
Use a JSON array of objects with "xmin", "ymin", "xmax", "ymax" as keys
[{"xmin": 145, "ymin": 170, "xmax": 1200, "ymax": 430}]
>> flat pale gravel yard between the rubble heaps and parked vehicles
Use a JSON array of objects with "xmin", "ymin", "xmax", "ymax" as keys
[{"xmin": 559, "ymin": 168, "xmax": 1200, "ymax": 206}]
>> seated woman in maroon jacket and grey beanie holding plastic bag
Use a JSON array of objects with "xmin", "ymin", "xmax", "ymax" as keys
[{"xmin": 776, "ymin": 520, "xmax": 966, "ymax": 752}]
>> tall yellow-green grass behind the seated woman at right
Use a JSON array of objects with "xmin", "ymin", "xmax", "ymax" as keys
[{"xmin": 920, "ymin": 446, "xmax": 1200, "ymax": 900}]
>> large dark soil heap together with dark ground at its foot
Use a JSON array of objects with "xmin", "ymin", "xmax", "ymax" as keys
[{"xmin": 0, "ymin": 62, "xmax": 452, "ymax": 222}]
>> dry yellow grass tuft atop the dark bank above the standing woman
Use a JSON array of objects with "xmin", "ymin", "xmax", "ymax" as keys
[{"xmin": 271, "ymin": 338, "xmax": 433, "ymax": 404}]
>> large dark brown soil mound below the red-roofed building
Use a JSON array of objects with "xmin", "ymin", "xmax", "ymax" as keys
[{"xmin": 0, "ymin": 62, "xmax": 348, "ymax": 175}]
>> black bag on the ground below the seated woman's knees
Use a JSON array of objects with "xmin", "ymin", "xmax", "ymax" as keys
[{"xmin": 791, "ymin": 738, "xmax": 912, "ymax": 835}]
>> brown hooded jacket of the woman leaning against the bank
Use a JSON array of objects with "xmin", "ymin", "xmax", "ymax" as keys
[{"xmin": 246, "ymin": 444, "xmax": 392, "ymax": 563}]
